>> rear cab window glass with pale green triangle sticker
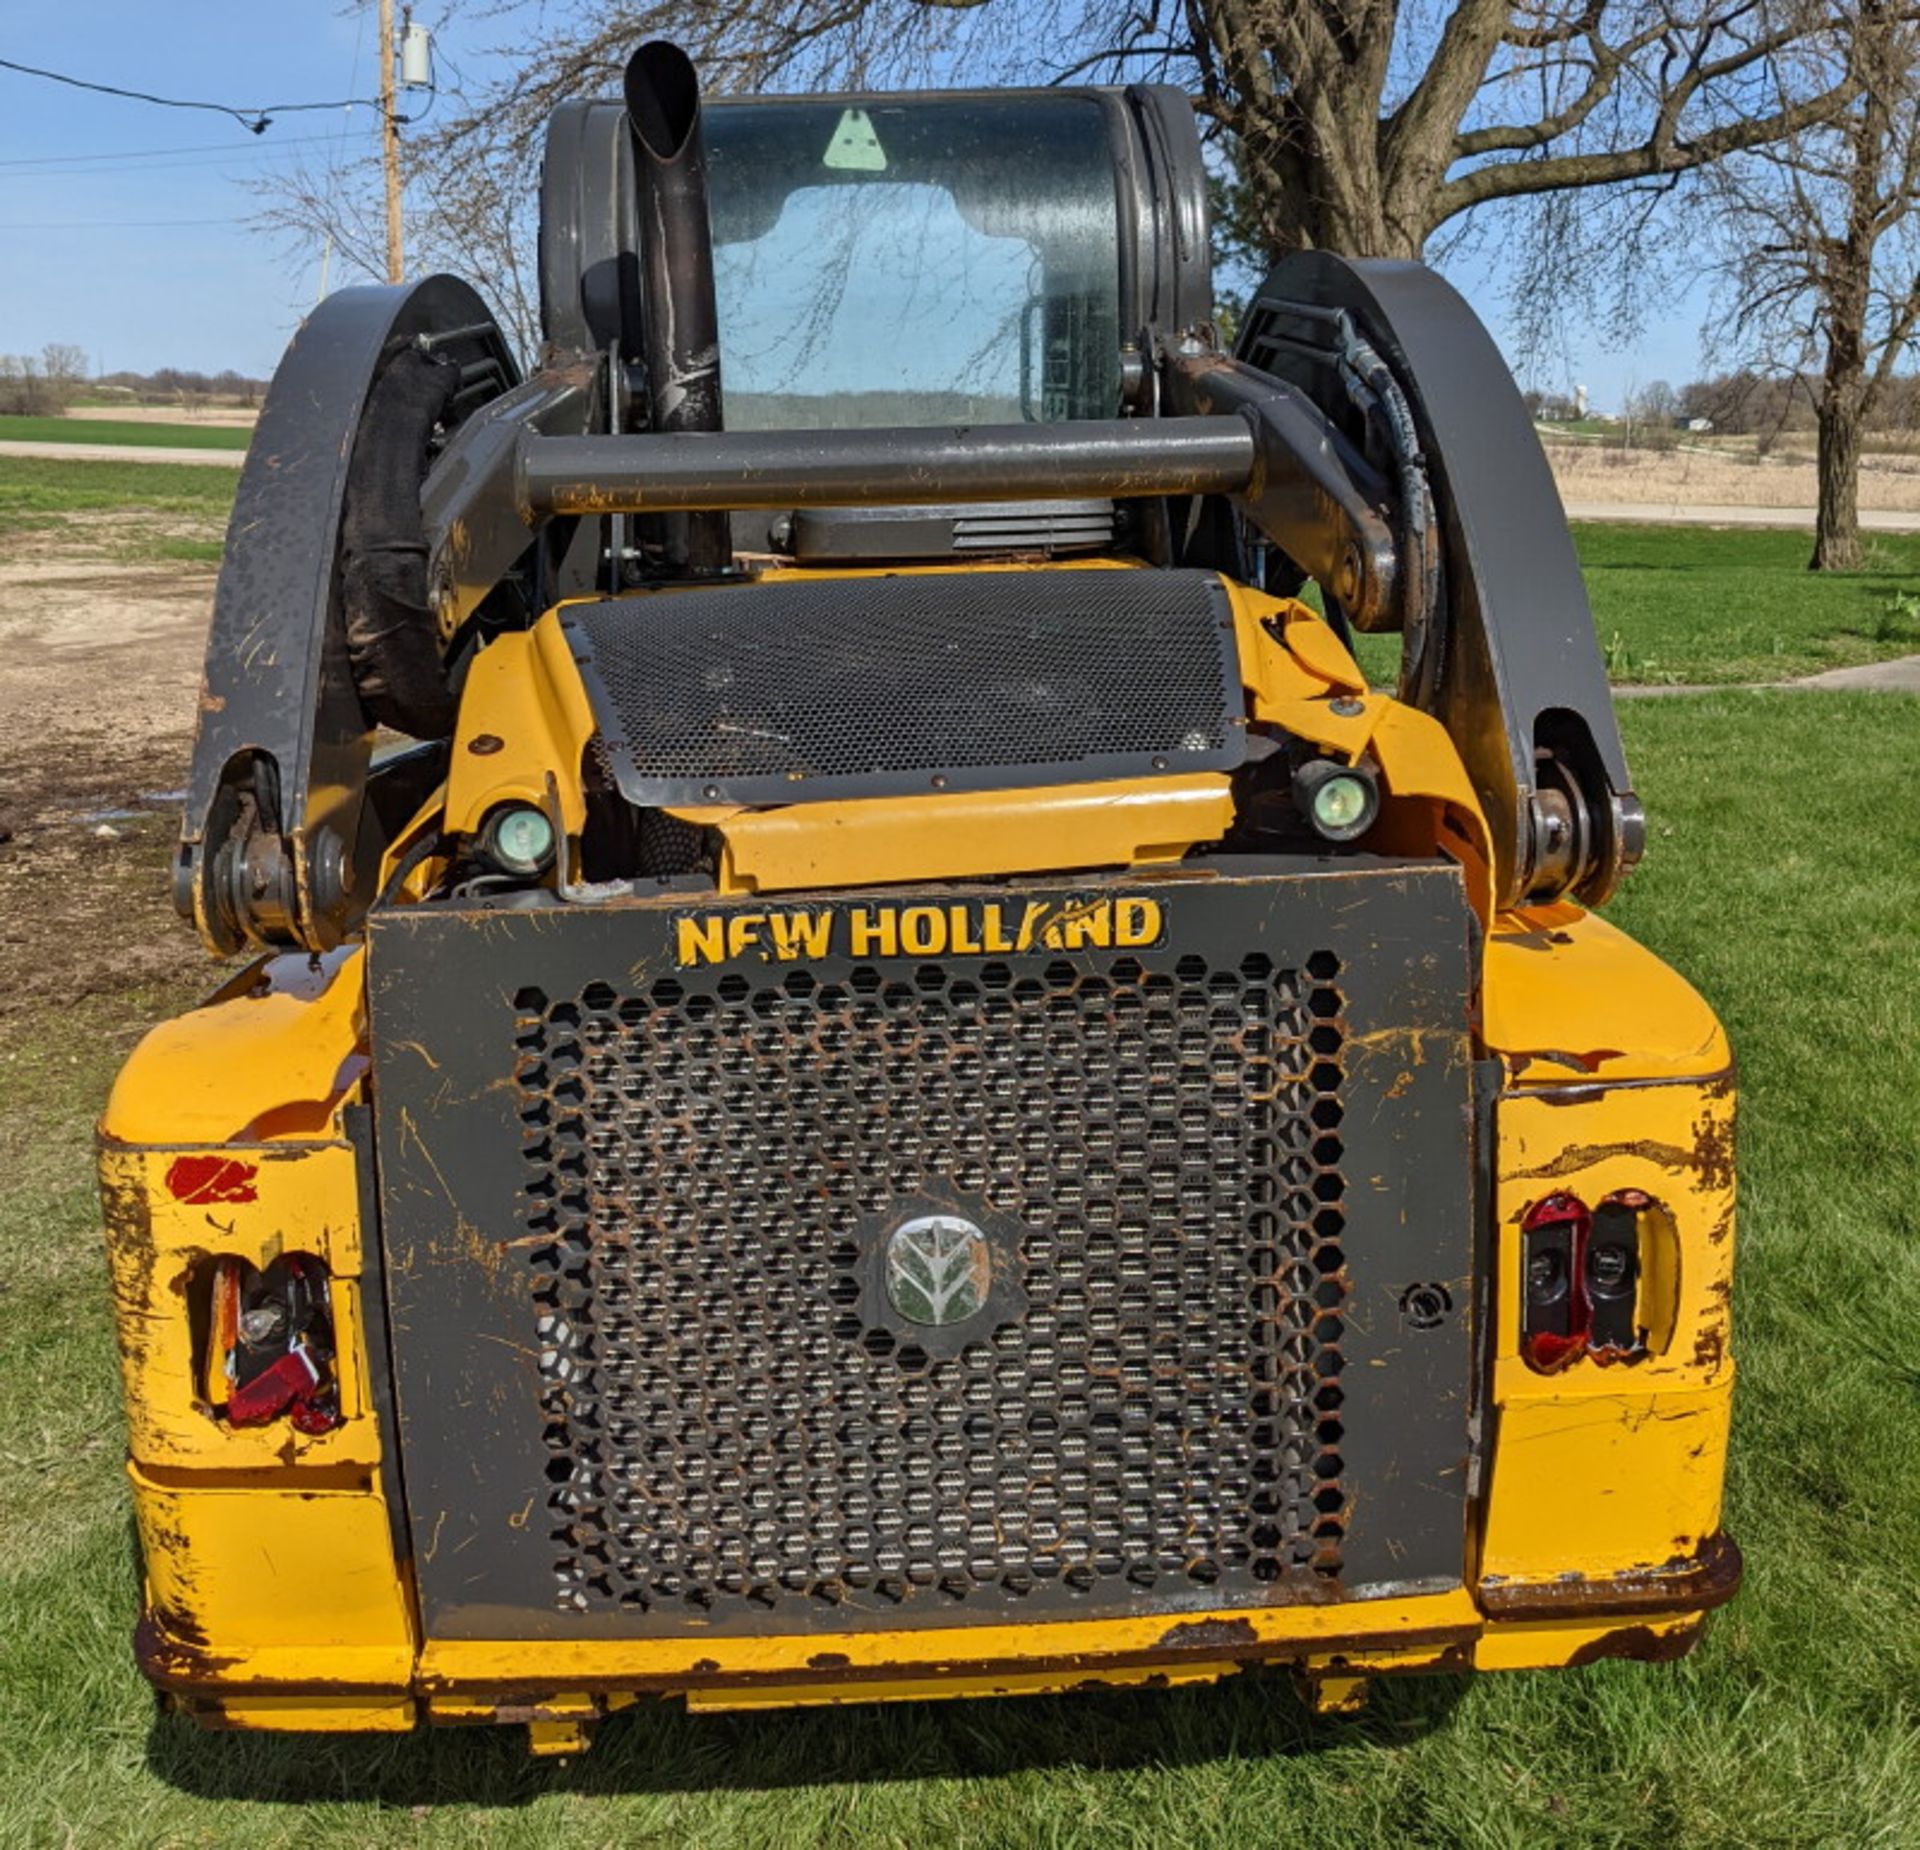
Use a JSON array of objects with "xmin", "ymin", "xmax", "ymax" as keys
[{"xmin": 707, "ymin": 96, "xmax": 1121, "ymax": 430}]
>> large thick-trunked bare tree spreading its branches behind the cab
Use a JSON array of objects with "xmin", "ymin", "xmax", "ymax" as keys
[{"xmin": 263, "ymin": 0, "xmax": 1853, "ymax": 364}]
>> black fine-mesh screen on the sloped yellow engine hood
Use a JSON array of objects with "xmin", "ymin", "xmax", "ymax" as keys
[{"xmin": 564, "ymin": 570, "xmax": 1246, "ymax": 804}]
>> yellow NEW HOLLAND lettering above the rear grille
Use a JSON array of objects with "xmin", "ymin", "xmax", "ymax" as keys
[{"xmin": 674, "ymin": 896, "xmax": 1167, "ymax": 965}]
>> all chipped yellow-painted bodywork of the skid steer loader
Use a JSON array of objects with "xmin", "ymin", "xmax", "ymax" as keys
[{"xmin": 100, "ymin": 574, "xmax": 1738, "ymax": 1750}]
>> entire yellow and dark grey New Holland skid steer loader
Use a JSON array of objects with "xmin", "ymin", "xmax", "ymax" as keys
[{"xmin": 100, "ymin": 44, "xmax": 1740, "ymax": 1750}]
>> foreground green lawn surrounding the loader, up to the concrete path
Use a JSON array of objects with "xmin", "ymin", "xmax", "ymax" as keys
[{"xmin": 0, "ymin": 693, "xmax": 1920, "ymax": 1850}]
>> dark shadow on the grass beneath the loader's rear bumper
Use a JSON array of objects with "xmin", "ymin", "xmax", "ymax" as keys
[{"xmin": 146, "ymin": 1672, "xmax": 1467, "ymax": 1808}]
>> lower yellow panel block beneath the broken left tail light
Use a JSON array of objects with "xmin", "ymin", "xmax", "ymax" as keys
[{"xmin": 129, "ymin": 1466, "xmax": 413, "ymax": 1693}]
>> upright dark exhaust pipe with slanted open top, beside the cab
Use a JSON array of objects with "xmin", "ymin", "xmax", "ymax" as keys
[{"xmin": 626, "ymin": 38, "xmax": 733, "ymax": 576}]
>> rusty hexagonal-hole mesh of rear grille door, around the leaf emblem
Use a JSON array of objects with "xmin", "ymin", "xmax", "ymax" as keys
[{"xmin": 515, "ymin": 952, "xmax": 1348, "ymax": 1631}]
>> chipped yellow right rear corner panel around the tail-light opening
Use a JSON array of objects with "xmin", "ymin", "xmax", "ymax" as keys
[{"xmin": 1480, "ymin": 906, "xmax": 1734, "ymax": 1583}]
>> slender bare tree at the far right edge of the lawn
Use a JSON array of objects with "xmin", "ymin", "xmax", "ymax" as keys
[{"xmin": 1716, "ymin": 0, "xmax": 1920, "ymax": 572}]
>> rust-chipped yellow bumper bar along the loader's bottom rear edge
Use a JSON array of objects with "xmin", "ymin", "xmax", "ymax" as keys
[{"xmin": 134, "ymin": 1533, "xmax": 1741, "ymax": 1729}]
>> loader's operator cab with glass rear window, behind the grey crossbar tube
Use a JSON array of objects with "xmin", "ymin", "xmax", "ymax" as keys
[{"xmin": 541, "ymin": 84, "xmax": 1212, "ymax": 564}]
